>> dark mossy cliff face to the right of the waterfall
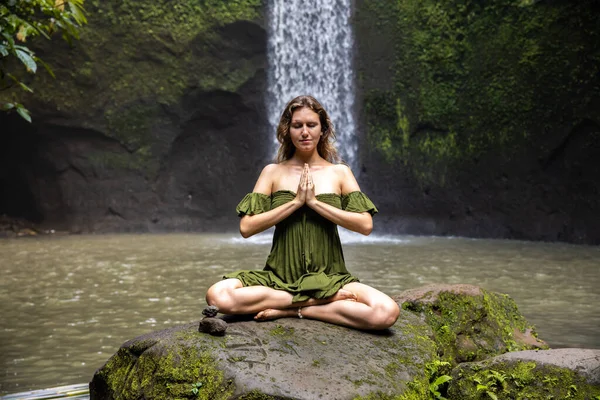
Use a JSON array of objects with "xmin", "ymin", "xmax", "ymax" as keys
[{"xmin": 355, "ymin": 0, "xmax": 600, "ymax": 244}]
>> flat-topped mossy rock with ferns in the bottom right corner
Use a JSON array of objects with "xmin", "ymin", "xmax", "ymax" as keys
[{"xmin": 448, "ymin": 349, "xmax": 600, "ymax": 400}]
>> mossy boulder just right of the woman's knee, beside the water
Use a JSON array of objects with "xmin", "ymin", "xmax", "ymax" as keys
[{"xmin": 394, "ymin": 284, "xmax": 548, "ymax": 365}]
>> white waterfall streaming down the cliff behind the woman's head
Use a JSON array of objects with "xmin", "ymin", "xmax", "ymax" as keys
[{"xmin": 267, "ymin": 0, "xmax": 357, "ymax": 166}]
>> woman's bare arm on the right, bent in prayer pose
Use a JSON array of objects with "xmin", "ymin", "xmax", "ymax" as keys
[{"xmin": 306, "ymin": 165, "xmax": 373, "ymax": 235}]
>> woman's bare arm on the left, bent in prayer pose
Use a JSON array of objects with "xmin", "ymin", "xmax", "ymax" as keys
[{"xmin": 240, "ymin": 164, "xmax": 304, "ymax": 238}]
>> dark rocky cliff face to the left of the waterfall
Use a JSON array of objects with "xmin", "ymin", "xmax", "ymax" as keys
[{"xmin": 0, "ymin": 0, "xmax": 270, "ymax": 232}]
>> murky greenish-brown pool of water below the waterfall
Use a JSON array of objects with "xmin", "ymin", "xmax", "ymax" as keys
[{"xmin": 0, "ymin": 231, "xmax": 600, "ymax": 395}]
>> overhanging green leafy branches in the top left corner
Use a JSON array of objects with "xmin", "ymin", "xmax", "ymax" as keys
[{"xmin": 0, "ymin": 0, "xmax": 87, "ymax": 122}]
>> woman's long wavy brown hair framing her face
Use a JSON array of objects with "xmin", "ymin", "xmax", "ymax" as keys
[{"xmin": 277, "ymin": 96, "xmax": 341, "ymax": 164}]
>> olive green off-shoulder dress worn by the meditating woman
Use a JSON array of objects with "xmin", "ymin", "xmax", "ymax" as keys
[{"xmin": 224, "ymin": 190, "xmax": 377, "ymax": 303}]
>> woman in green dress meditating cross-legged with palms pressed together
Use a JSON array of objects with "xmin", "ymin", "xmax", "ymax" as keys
[{"xmin": 206, "ymin": 96, "xmax": 400, "ymax": 329}]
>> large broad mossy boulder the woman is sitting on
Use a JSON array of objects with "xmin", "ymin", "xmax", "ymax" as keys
[{"xmin": 90, "ymin": 313, "xmax": 437, "ymax": 400}]
